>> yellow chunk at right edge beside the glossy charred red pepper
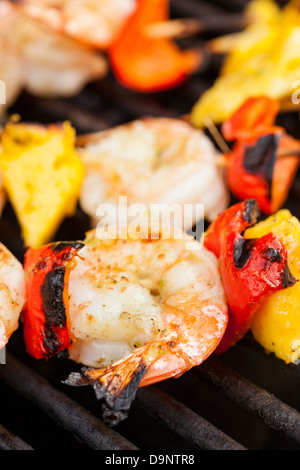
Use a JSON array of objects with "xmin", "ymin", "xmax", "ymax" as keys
[{"xmin": 245, "ymin": 209, "xmax": 300, "ymax": 363}]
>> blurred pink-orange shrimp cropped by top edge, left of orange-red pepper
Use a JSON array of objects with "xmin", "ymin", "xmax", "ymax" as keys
[{"xmin": 19, "ymin": 0, "xmax": 136, "ymax": 49}]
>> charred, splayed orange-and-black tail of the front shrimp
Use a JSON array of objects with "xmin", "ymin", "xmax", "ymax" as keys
[{"xmin": 64, "ymin": 354, "xmax": 149, "ymax": 427}]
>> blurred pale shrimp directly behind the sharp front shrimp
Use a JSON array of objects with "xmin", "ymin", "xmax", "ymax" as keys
[{"xmin": 78, "ymin": 118, "xmax": 228, "ymax": 230}]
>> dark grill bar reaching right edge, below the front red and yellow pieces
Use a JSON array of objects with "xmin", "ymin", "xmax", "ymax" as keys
[{"xmin": 193, "ymin": 356, "xmax": 300, "ymax": 445}]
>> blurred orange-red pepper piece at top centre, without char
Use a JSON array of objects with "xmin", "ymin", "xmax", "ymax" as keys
[{"xmin": 108, "ymin": 0, "xmax": 201, "ymax": 92}]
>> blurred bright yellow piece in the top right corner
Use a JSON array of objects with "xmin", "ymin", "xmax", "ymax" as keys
[{"xmin": 190, "ymin": 0, "xmax": 300, "ymax": 127}]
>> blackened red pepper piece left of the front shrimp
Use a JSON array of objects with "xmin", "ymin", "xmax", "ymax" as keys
[{"xmin": 23, "ymin": 242, "xmax": 83, "ymax": 359}]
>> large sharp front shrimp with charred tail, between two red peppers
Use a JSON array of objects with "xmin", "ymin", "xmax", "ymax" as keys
[{"xmin": 66, "ymin": 228, "xmax": 227, "ymax": 424}]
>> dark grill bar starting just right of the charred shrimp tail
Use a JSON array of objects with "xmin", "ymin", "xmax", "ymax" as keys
[{"xmin": 136, "ymin": 387, "xmax": 246, "ymax": 450}]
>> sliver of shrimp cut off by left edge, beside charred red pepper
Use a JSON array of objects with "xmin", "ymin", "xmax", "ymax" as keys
[{"xmin": 0, "ymin": 243, "xmax": 25, "ymax": 349}]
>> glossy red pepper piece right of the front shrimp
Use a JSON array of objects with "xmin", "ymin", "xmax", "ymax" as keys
[{"xmin": 204, "ymin": 200, "xmax": 296, "ymax": 354}]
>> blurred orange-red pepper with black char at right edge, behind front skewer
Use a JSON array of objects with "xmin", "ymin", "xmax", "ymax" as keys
[{"xmin": 222, "ymin": 97, "xmax": 300, "ymax": 214}]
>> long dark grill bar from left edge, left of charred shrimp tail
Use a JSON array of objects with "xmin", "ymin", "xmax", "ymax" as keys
[{"xmin": 0, "ymin": 353, "xmax": 138, "ymax": 451}]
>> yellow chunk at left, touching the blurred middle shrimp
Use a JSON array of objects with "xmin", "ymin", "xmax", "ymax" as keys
[{"xmin": 0, "ymin": 122, "xmax": 84, "ymax": 248}]
